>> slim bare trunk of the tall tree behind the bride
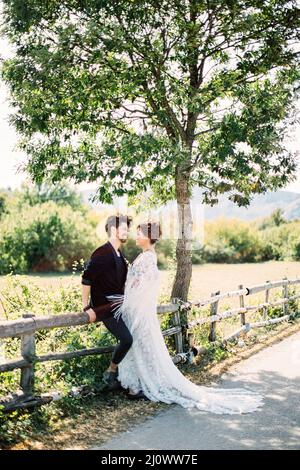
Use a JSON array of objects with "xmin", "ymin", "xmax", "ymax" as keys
[{"xmin": 171, "ymin": 171, "xmax": 193, "ymax": 300}]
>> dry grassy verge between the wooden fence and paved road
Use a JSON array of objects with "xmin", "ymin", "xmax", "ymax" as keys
[{"xmin": 4, "ymin": 321, "xmax": 300, "ymax": 450}]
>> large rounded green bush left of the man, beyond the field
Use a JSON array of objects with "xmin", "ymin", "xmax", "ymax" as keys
[{"xmin": 0, "ymin": 201, "xmax": 96, "ymax": 274}]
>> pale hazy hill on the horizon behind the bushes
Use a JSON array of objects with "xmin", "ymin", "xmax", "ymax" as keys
[{"xmin": 81, "ymin": 188, "xmax": 300, "ymax": 220}]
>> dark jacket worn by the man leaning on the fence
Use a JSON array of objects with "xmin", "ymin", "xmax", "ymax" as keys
[{"xmin": 81, "ymin": 242, "xmax": 128, "ymax": 321}]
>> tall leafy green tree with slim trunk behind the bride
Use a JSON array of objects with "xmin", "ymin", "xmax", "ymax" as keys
[{"xmin": 3, "ymin": 0, "xmax": 299, "ymax": 299}]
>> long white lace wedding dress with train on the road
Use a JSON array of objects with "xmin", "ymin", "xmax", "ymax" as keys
[{"xmin": 108, "ymin": 250, "xmax": 263, "ymax": 414}]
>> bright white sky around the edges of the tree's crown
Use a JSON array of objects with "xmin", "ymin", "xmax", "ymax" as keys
[{"xmin": 0, "ymin": 34, "xmax": 300, "ymax": 193}]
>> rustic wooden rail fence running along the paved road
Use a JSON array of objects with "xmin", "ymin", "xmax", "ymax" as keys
[{"xmin": 0, "ymin": 278, "xmax": 300, "ymax": 411}]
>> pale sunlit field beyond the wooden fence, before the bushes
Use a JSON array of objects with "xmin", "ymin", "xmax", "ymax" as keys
[{"xmin": 0, "ymin": 261, "xmax": 300, "ymax": 335}]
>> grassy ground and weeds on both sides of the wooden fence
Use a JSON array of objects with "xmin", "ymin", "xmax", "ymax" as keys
[{"xmin": 0, "ymin": 261, "xmax": 300, "ymax": 449}]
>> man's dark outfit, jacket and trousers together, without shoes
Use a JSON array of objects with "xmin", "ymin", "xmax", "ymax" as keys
[{"xmin": 81, "ymin": 242, "xmax": 132, "ymax": 364}]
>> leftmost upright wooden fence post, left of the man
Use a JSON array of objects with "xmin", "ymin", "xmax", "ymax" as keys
[{"xmin": 20, "ymin": 313, "xmax": 35, "ymax": 396}]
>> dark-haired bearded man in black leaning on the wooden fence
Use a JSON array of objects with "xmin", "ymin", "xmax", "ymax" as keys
[{"xmin": 81, "ymin": 215, "xmax": 132, "ymax": 390}]
